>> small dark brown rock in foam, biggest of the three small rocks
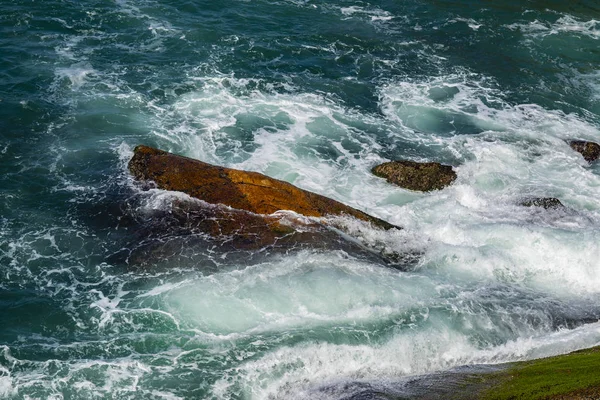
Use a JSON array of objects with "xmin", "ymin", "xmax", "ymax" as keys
[{"xmin": 372, "ymin": 161, "xmax": 456, "ymax": 192}]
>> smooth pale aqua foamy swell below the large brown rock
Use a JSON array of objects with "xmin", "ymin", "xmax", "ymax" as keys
[{"xmin": 164, "ymin": 252, "xmax": 432, "ymax": 339}]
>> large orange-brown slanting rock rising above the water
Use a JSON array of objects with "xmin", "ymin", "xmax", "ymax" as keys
[{"xmin": 129, "ymin": 145, "xmax": 395, "ymax": 229}]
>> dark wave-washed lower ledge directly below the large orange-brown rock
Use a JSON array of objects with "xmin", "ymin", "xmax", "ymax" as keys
[{"xmin": 110, "ymin": 198, "xmax": 412, "ymax": 273}]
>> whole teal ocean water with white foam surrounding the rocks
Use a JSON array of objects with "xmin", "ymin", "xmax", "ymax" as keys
[{"xmin": 0, "ymin": 0, "xmax": 600, "ymax": 399}]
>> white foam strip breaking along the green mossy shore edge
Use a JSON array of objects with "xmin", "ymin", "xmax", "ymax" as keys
[{"xmin": 214, "ymin": 324, "xmax": 600, "ymax": 399}]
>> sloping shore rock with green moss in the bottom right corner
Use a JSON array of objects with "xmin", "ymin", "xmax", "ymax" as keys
[{"xmin": 319, "ymin": 346, "xmax": 600, "ymax": 400}]
